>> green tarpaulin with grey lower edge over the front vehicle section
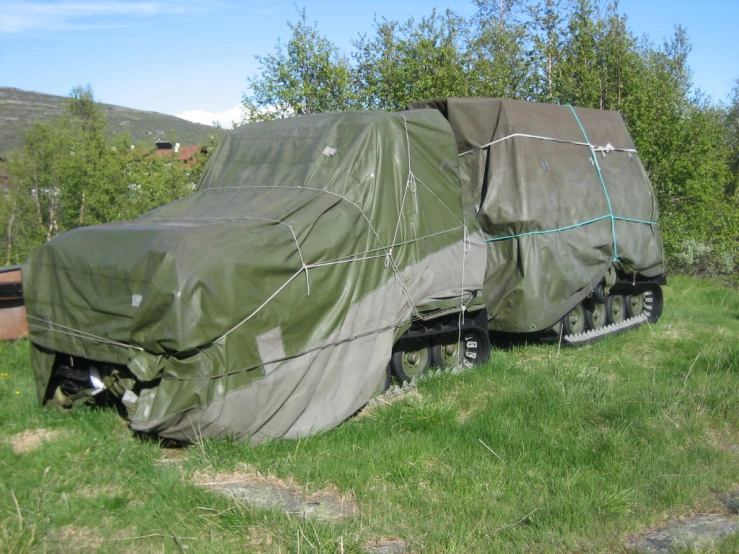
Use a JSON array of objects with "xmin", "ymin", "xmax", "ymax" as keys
[{"xmin": 23, "ymin": 110, "xmax": 486, "ymax": 443}]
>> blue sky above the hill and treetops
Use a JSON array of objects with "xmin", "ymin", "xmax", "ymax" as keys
[{"xmin": 0, "ymin": 0, "xmax": 739, "ymax": 125}]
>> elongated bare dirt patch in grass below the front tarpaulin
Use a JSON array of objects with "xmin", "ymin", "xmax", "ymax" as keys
[{"xmin": 193, "ymin": 467, "xmax": 359, "ymax": 520}]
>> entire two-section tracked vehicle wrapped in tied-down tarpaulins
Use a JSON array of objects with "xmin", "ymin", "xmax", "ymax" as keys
[{"xmin": 23, "ymin": 99, "xmax": 665, "ymax": 443}]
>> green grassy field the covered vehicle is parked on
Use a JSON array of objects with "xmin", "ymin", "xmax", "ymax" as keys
[{"xmin": 0, "ymin": 277, "xmax": 739, "ymax": 553}]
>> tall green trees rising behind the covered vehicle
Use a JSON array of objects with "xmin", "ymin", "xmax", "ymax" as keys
[{"xmin": 246, "ymin": 0, "xmax": 739, "ymax": 279}]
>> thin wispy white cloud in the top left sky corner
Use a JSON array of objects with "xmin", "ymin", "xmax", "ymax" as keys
[{"xmin": 0, "ymin": 0, "xmax": 194, "ymax": 33}]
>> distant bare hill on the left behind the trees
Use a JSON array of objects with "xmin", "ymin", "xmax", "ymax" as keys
[{"xmin": 0, "ymin": 87, "xmax": 218, "ymax": 156}]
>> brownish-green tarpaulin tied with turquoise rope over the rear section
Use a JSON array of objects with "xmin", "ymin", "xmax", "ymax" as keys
[{"xmin": 408, "ymin": 98, "xmax": 665, "ymax": 332}]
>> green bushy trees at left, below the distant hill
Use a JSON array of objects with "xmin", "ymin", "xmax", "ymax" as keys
[{"xmin": 0, "ymin": 87, "xmax": 217, "ymax": 265}]
